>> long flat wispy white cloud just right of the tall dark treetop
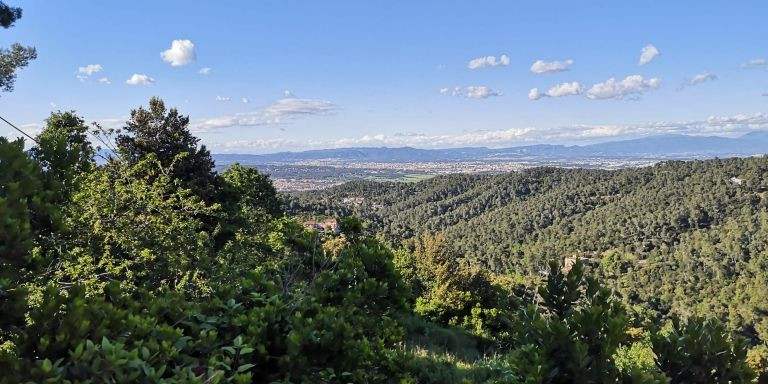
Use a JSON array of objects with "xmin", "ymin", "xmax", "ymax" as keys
[{"xmin": 192, "ymin": 91, "xmax": 338, "ymax": 132}]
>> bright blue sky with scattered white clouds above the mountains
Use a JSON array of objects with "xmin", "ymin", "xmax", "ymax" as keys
[{"xmin": 0, "ymin": 0, "xmax": 768, "ymax": 153}]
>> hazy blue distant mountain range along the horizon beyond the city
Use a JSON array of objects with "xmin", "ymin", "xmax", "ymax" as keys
[{"xmin": 214, "ymin": 131, "xmax": 768, "ymax": 166}]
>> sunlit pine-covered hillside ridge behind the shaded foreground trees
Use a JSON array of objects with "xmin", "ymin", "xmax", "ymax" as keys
[{"xmin": 288, "ymin": 157, "xmax": 768, "ymax": 364}]
